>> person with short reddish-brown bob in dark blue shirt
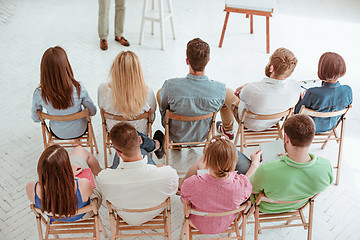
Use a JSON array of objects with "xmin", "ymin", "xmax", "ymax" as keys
[{"xmin": 295, "ymin": 52, "xmax": 353, "ymax": 133}]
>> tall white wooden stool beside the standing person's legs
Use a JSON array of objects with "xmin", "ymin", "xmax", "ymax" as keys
[{"xmin": 139, "ymin": 0, "xmax": 175, "ymax": 50}]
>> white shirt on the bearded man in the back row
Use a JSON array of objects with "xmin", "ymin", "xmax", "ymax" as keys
[{"xmin": 238, "ymin": 78, "xmax": 302, "ymax": 131}]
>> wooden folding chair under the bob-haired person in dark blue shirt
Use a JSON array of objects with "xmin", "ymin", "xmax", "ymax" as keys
[{"xmin": 299, "ymin": 105, "xmax": 351, "ymax": 185}]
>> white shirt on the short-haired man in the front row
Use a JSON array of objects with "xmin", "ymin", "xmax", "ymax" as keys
[{"xmin": 96, "ymin": 156, "xmax": 179, "ymax": 225}]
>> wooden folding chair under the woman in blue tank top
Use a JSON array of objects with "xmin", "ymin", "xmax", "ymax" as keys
[{"xmin": 30, "ymin": 201, "xmax": 107, "ymax": 240}]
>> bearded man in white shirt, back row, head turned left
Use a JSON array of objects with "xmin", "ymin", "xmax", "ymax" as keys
[{"xmin": 238, "ymin": 48, "xmax": 301, "ymax": 131}]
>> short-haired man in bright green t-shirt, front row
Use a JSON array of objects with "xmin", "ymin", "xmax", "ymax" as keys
[{"xmin": 249, "ymin": 114, "xmax": 333, "ymax": 213}]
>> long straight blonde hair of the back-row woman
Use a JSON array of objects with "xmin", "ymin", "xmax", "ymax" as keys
[{"xmin": 110, "ymin": 51, "xmax": 149, "ymax": 118}]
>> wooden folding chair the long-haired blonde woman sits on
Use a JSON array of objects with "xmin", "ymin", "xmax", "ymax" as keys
[{"xmin": 100, "ymin": 109, "xmax": 152, "ymax": 168}]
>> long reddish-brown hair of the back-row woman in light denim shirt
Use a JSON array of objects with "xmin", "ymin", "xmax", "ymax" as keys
[{"xmin": 40, "ymin": 46, "xmax": 81, "ymax": 109}]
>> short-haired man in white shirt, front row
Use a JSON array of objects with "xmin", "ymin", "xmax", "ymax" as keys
[{"xmin": 96, "ymin": 122, "xmax": 179, "ymax": 225}]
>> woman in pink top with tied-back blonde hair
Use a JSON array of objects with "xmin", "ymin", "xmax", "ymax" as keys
[{"xmin": 181, "ymin": 136, "xmax": 252, "ymax": 234}]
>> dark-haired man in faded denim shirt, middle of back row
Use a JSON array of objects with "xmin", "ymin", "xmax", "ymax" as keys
[{"xmin": 158, "ymin": 38, "xmax": 226, "ymax": 142}]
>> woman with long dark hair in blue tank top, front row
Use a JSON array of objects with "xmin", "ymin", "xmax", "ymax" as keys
[{"xmin": 26, "ymin": 144, "xmax": 101, "ymax": 223}]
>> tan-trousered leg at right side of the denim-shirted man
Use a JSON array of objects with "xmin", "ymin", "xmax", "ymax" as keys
[{"xmin": 220, "ymin": 88, "xmax": 240, "ymax": 131}]
